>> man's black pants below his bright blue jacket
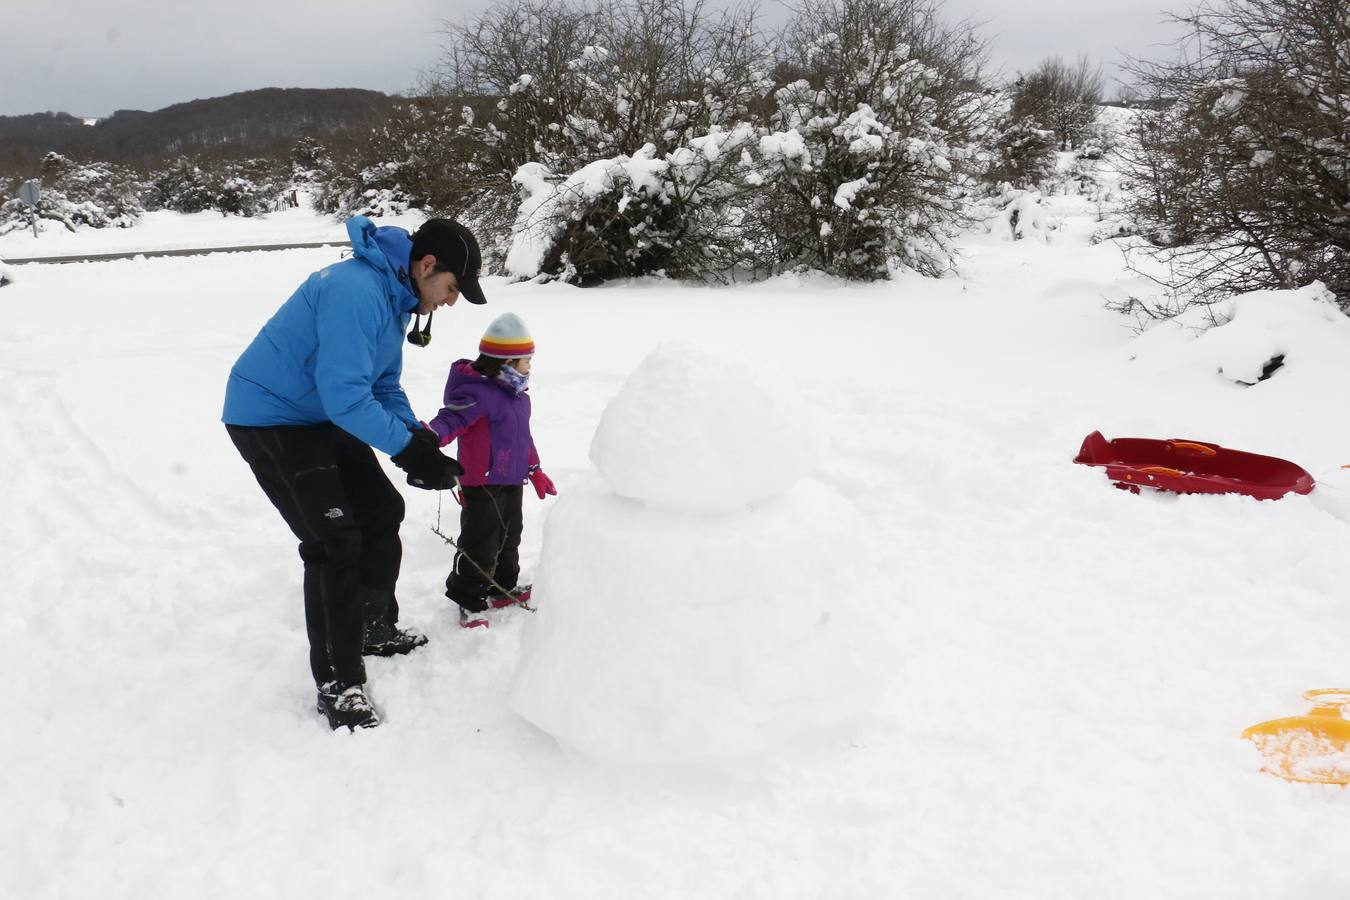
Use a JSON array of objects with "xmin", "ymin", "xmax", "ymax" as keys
[{"xmin": 225, "ymin": 424, "xmax": 404, "ymax": 684}]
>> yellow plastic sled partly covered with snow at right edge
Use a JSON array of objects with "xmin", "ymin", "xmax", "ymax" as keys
[{"xmin": 1242, "ymin": 688, "xmax": 1350, "ymax": 784}]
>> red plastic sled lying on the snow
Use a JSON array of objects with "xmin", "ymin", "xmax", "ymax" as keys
[{"xmin": 1073, "ymin": 432, "xmax": 1315, "ymax": 501}]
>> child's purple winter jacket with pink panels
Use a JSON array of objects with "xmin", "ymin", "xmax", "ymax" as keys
[{"xmin": 427, "ymin": 359, "xmax": 539, "ymax": 487}]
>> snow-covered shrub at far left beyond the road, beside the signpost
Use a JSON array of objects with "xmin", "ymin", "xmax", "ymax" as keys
[{"xmin": 0, "ymin": 152, "xmax": 144, "ymax": 233}]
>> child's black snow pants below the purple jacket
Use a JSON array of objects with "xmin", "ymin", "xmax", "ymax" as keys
[{"xmin": 446, "ymin": 484, "xmax": 524, "ymax": 610}]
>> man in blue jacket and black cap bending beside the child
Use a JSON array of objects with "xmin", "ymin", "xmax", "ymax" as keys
[{"xmin": 221, "ymin": 216, "xmax": 487, "ymax": 729}]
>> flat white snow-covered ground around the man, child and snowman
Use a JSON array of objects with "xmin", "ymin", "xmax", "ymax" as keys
[{"xmin": 0, "ymin": 184, "xmax": 1350, "ymax": 900}]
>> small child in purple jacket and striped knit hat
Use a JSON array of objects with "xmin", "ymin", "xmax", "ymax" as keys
[{"xmin": 429, "ymin": 313, "xmax": 558, "ymax": 627}]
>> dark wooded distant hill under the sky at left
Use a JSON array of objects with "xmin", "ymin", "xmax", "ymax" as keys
[{"xmin": 0, "ymin": 88, "xmax": 397, "ymax": 174}]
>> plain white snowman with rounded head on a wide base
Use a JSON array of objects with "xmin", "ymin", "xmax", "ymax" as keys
[{"xmin": 512, "ymin": 344, "xmax": 887, "ymax": 762}]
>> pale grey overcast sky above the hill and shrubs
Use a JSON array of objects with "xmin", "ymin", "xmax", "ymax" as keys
[{"xmin": 0, "ymin": 0, "xmax": 1191, "ymax": 116}]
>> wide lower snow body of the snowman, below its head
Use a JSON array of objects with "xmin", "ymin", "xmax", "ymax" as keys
[{"xmin": 513, "ymin": 474, "xmax": 894, "ymax": 764}]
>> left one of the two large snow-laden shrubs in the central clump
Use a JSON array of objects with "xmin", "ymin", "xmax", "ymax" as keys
[{"xmin": 440, "ymin": 0, "xmax": 770, "ymax": 283}]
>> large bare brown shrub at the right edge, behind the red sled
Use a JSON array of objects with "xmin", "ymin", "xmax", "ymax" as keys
[{"xmin": 1129, "ymin": 0, "xmax": 1350, "ymax": 310}]
